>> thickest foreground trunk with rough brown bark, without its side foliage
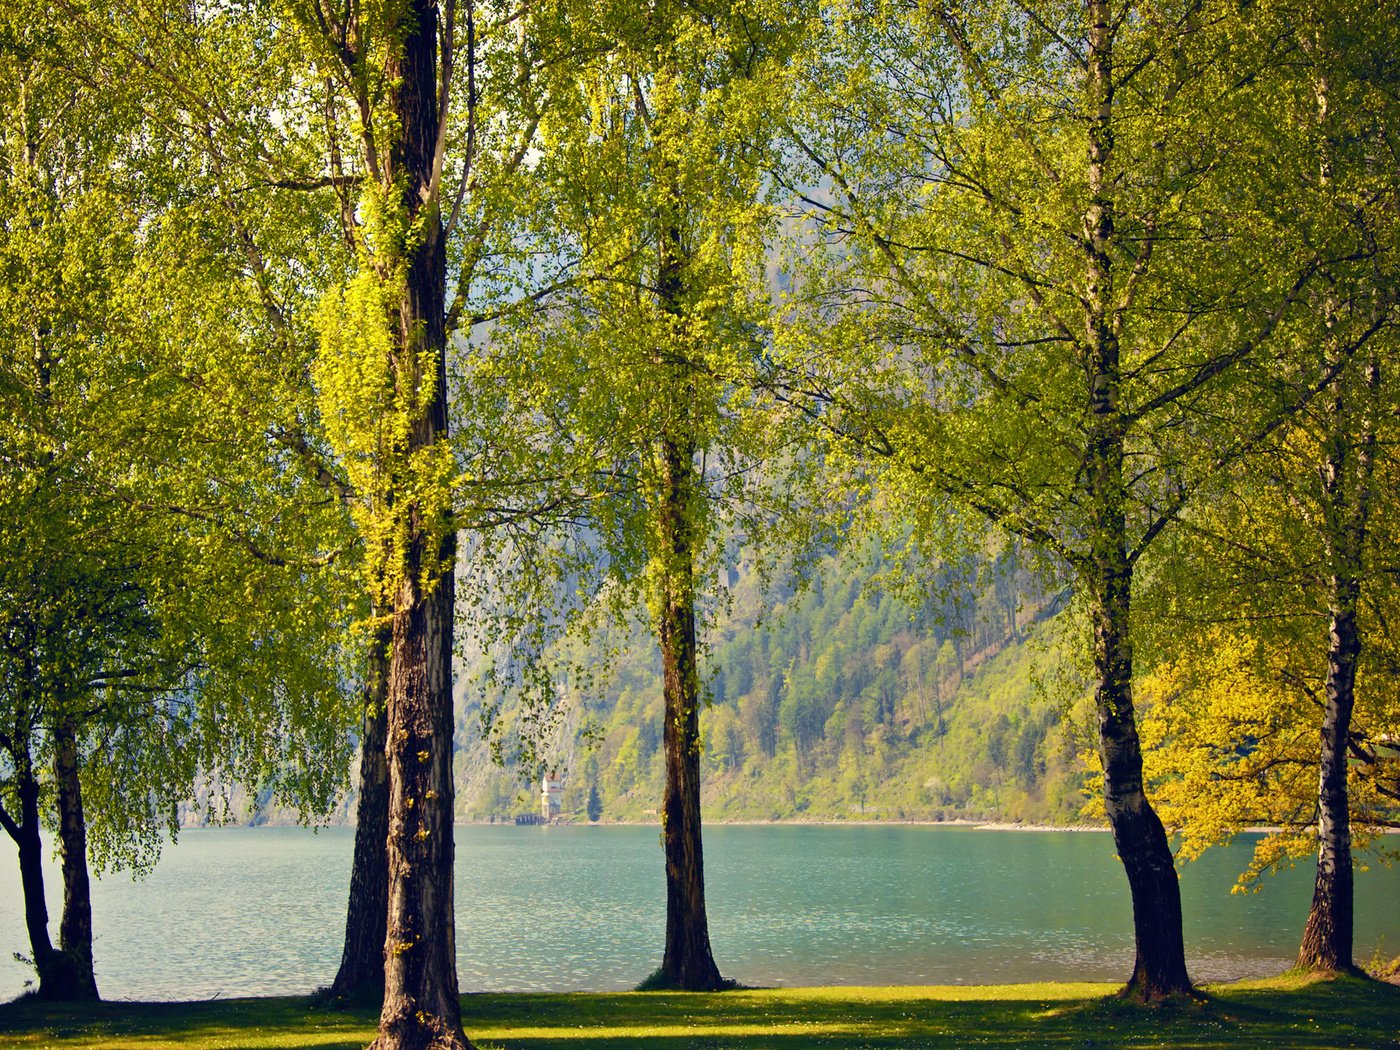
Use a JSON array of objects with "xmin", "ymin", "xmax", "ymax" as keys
[{"xmin": 374, "ymin": 0, "xmax": 470, "ymax": 1050}]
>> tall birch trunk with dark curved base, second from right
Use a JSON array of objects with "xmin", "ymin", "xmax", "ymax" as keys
[{"xmin": 1081, "ymin": 0, "xmax": 1191, "ymax": 1000}]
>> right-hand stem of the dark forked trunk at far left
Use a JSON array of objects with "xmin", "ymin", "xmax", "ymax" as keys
[{"xmin": 46, "ymin": 720, "xmax": 98, "ymax": 1000}]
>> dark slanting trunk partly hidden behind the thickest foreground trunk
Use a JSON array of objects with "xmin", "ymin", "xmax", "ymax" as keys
[{"xmin": 330, "ymin": 630, "xmax": 392, "ymax": 1004}]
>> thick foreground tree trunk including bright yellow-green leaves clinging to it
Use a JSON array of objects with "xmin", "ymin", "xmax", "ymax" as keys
[{"xmin": 302, "ymin": 0, "xmax": 476, "ymax": 1047}]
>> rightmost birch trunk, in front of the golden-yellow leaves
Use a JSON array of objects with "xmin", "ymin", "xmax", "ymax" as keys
[{"xmin": 1298, "ymin": 360, "xmax": 1380, "ymax": 970}]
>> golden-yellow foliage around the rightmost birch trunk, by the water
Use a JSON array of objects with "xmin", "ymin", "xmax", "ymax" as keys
[{"xmin": 1144, "ymin": 378, "xmax": 1400, "ymax": 886}]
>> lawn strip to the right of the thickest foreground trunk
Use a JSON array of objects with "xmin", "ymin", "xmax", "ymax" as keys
[{"xmin": 463, "ymin": 980, "xmax": 1400, "ymax": 1050}]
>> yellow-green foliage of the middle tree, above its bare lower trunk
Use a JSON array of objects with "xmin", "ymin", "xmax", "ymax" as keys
[{"xmin": 456, "ymin": 3, "xmax": 819, "ymax": 762}]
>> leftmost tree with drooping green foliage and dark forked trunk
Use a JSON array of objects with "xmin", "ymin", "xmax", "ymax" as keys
[{"xmin": 0, "ymin": 7, "xmax": 361, "ymax": 998}]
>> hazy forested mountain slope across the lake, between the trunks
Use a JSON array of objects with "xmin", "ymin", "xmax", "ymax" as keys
[{"xmin": 456, "ymin": 553, "xmax": 1089, "ymax": 823}]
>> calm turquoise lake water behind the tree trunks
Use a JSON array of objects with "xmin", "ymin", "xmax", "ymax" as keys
[{"xmin": 0, "ymin": 826, "xmax": 1400, "ymax": 1000}]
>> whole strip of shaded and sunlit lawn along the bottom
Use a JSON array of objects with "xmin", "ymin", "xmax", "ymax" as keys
[{"xmin": 0, "ymin": 974, "xmax": 1400, "ymax": 1050}]
